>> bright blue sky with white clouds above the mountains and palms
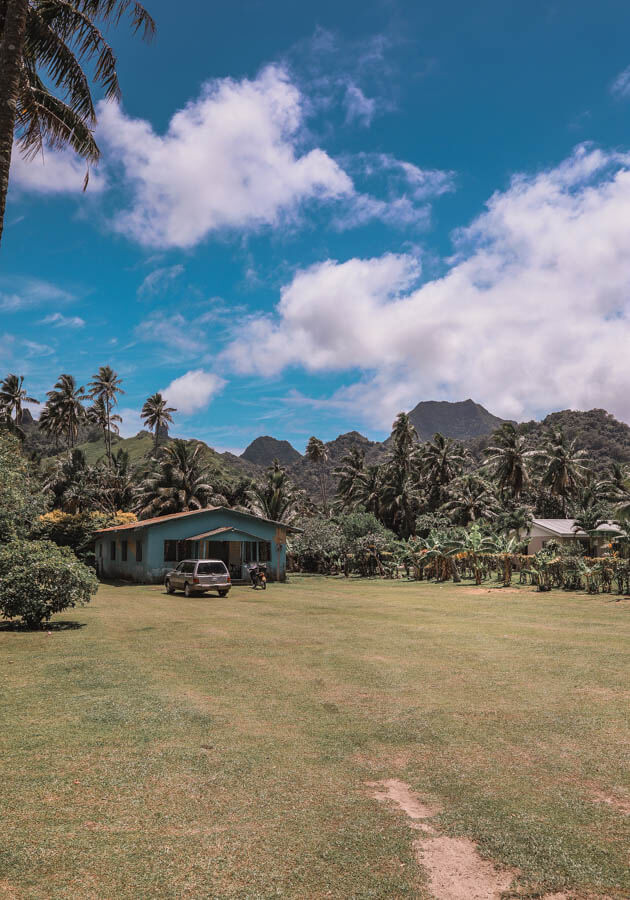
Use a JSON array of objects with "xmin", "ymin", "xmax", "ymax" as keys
[{"xmin": 0, "ymin": 0, "xmax": 630, "ymax": 450}]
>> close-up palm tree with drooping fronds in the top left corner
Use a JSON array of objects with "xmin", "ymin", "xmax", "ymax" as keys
[{"xmin": 0, "ymin": 0, "xmax": 155, "ymax": 240}]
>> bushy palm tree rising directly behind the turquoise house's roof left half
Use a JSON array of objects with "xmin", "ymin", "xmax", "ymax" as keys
[{"xmin": 136, "ymin": 438, "xmax": 213, "ymax": 519}]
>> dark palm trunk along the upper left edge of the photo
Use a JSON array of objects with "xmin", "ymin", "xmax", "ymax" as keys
[{"xmin": 0, "ymin": 0, "xmax": 28, "ymax": 241}]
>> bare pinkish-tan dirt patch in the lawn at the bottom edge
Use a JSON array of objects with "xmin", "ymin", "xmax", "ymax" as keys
[{"xmin": 367, "ymin": 778, "xmax": 569, "ymax": 900}]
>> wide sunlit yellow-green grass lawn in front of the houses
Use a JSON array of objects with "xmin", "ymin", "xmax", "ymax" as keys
[{"xmin": 0, "ymin": 576, "xmax": 630, "ymax": 900}]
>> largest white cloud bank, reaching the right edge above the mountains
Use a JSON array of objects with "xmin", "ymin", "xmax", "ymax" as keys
[{"xmin": 226, "ymin": 146, "xmax": 630, "ymax": 427}]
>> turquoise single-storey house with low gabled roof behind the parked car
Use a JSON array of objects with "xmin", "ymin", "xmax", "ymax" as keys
[{"xmin": 95, "ymin": 506, "xmax": 299, "ymax": 584}]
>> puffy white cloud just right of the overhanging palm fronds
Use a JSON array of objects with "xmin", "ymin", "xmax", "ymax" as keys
[{"xmin": 99, "ymin": 66, "xmax": 353, "ymax": 247}]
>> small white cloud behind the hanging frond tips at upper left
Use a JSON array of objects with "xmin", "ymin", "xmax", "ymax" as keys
[{"xmin": 11, "ymin": 145, "xmax": 105, "ymax": 194}]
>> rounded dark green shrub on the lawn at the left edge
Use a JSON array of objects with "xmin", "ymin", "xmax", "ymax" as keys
[{"xmin": 0, "ymin": 541, "xmax": 98, "ymax": 628}]
